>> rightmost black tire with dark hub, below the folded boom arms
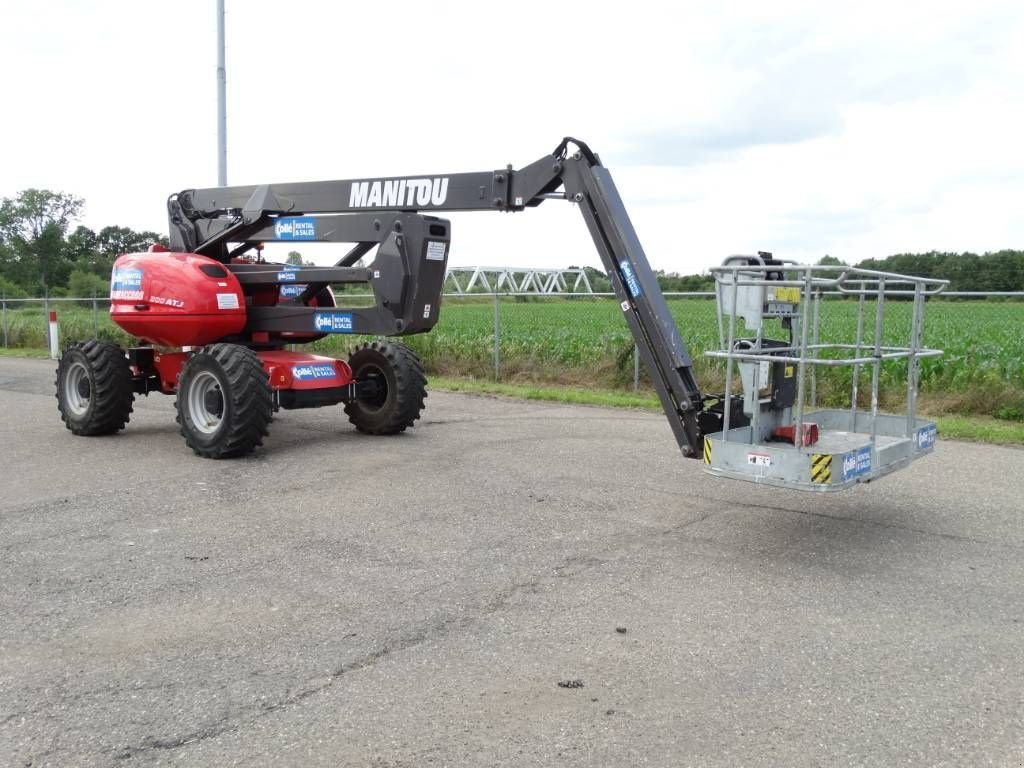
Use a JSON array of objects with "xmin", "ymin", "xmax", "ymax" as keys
[{"xmin": 345, "ymin": 341, "xmax": 427, "ymax": 434}]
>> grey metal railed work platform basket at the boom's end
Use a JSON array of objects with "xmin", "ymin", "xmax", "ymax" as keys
[{"xmin": 703, "ymin": 259, "xmax": 946, "ymax": 492}]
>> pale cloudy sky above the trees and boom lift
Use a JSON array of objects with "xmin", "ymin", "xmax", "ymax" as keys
[{"xmin": 0, "ymin": 0, "xmax": 1024, "ymax": 273}]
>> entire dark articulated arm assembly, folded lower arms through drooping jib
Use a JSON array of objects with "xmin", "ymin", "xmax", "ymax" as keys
[{"xmin": 168, "ymin": 137, "xmax": 702, "ymax": 457}]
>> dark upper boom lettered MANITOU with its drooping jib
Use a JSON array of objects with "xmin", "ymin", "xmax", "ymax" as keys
[{"xmin": 168, "ymin": 137, "xmax": 702, "ymax": 457}]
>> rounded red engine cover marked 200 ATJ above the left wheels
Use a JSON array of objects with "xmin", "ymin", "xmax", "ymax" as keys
[{"xmin": 111, "ymin": 246, "xmax": 246, "ymax": 347}]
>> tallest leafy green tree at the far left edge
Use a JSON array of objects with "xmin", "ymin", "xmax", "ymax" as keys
[{"xmin": 0, "ymin": 189, "xmax": 83, "ymax": 292}]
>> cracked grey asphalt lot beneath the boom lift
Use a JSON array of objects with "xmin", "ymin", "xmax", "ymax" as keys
[{"xmin": 0, "ymin": 358, "xmax": 1024, "ymax": 768}]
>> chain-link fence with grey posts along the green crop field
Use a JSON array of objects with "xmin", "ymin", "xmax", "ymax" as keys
[{"xmin": 0, "ymin": 293, "xmax": 1024, "ymax": 420}]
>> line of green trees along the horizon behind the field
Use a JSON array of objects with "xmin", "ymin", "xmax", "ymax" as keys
[{"xmin": 0, "ymin": 189, "xmax": 1024, "ymax": 298}]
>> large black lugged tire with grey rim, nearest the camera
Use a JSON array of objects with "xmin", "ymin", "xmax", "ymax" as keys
[{"xmin": 174, "ymin": 344, "xmax": 273, "ymax": 459}]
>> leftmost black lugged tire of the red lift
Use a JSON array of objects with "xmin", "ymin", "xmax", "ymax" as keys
[{"xmin": 54, "ymin": 339, "xmax": 135, "ymax": 436}]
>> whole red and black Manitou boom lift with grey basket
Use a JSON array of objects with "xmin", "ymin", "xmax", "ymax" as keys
[{"xmin": 57, "ymin": 137, "xmax": 941, "ymax": 489}]
